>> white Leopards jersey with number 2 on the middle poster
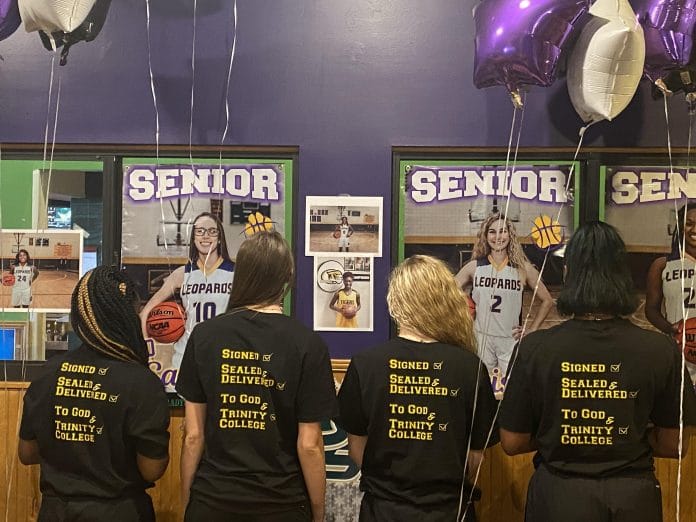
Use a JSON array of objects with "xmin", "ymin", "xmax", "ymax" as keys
[{"xmin": 471, "ymin": 258, "xmax": 523, "ymax": 337}]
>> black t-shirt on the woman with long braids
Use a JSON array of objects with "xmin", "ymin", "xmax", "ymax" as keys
[{"xmin": 19, "ymin": 346, "xmax": 169, "ymax": 499}]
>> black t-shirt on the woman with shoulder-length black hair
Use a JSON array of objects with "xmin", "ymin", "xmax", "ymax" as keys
[{"xmin": 500, "ymin": 319, "xmax": 696, "ymax": 476}]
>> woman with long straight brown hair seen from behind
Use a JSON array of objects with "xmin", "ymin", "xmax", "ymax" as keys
[{"xmin": 176, "ymin": 232, "xmax": 336, "ymax": 522}]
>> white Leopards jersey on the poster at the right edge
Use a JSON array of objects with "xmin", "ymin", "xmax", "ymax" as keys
[{"xmin": 662, "ymin": 254, "xmax": 696, "ymax": 323}]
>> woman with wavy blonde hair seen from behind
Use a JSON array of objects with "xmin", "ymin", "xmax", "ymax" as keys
[{"xmin": 339, "ymin": 256, "xmax": 498, "ymax": 522}]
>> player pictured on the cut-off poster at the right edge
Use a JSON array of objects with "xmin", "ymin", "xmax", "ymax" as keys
[{"xmin": 645, "ymin": 201, "xmax": 696, "ymax": 379}]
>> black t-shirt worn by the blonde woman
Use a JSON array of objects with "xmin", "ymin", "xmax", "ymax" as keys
[{"xmin": 338, "ymin": 338, "xmax": 498, "ymax": 506}]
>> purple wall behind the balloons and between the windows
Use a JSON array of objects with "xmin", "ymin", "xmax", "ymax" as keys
[{"xmin": 0, "ymin": 0, "xmax": 688, "ymax": 357}]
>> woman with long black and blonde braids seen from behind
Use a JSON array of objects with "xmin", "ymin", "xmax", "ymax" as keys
[{"xmin": 19, "ymin": 266, "xmax": 169, "ymax": 522}]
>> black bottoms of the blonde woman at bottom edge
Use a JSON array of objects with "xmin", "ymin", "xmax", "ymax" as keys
[{"xmin": 360, "ymin": 493, "xmax": 476, "ymax": 522}]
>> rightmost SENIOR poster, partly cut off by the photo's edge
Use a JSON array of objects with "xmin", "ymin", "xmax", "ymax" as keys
[{"xmin": 600, "ymin": 165, "xmax": 696, "ymax": 388}]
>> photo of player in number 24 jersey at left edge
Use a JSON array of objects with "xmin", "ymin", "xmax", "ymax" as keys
[{"xmin": 0, "ymin": 229, "xmax": 83, "ymax": 313}]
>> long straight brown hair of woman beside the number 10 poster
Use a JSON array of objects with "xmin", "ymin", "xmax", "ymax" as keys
[{"xmin": 227, "ymin": 231, "xmax": 295, "ymax": 311}]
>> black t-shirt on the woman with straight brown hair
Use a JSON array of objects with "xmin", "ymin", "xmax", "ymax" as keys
[{"xmin": 176, "ymin": 310, "xmax": 336, "ymax": 511}]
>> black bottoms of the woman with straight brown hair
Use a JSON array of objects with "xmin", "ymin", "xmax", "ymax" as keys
[{"xmin": 184, "ymin": 492, "xmax": 312, "ymax": 522}]
